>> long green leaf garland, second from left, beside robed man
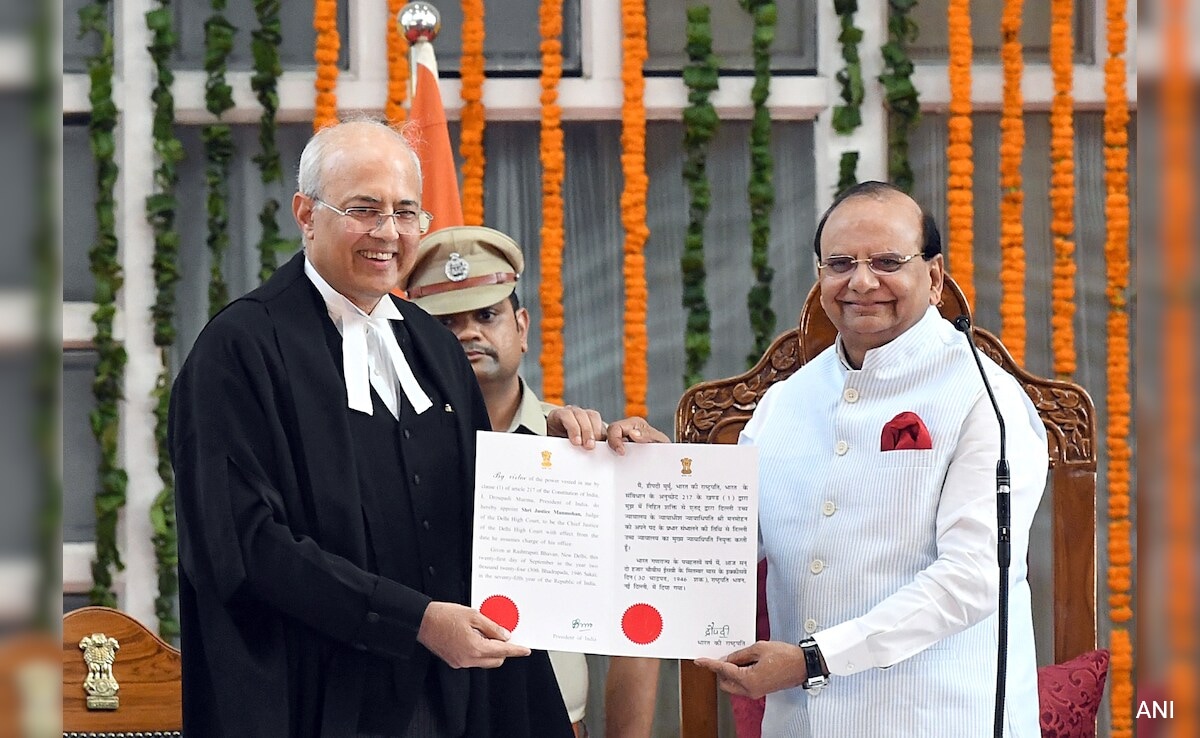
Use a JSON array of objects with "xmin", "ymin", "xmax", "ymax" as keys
[{"xmin": 145, "ymin": 0, "xmax": 184, "ymax": 641}]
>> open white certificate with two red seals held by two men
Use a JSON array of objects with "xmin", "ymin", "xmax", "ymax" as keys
[{"xmin": 470, "ymin": 431, "xmax": 758, "ymax": 659}]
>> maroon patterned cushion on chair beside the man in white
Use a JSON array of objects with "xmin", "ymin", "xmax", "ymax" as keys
[{"xmin": 1038, "ymin": 649, "xmax": 1109, "ymax": 738}]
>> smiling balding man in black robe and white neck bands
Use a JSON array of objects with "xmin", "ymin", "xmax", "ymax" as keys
[{"xmin": 170, "ymin": 120, "xmax": 580, "ymax": 738}]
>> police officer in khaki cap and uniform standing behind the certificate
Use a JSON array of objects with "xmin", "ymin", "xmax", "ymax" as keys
[{"xmin": 408, "ymin": 226, "xmax": 668, "ymax": 738}]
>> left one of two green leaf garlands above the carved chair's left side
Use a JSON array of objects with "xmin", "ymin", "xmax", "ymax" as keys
[{"xmin": 680, "ymin": 5, "xmax": 720, "ymax": 389}]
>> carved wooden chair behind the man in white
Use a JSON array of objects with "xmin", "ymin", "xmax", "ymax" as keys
[{"xmin": 676, "ymin": 277, "xmax": 1096, "ymax": 738}]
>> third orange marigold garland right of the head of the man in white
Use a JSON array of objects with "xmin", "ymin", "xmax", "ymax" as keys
[{"xmin": 1050, "ymin": 0, "xmax": 1075, "ymax": 379}]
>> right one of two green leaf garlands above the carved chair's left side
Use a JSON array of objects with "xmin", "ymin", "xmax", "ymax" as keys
[{"xmin": 738, "ymin": 0, "xmax": 775, "ymax": 367}]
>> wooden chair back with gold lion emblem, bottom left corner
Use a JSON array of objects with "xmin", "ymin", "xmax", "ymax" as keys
[{"xmin": 62, "ymin": 607, "xmax": 184, "ymax": 738}]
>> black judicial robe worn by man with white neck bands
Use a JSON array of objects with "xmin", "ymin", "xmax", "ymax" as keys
[{"xmin": 169, "ymin": 253, "xmax": 571, "ymax": 738}]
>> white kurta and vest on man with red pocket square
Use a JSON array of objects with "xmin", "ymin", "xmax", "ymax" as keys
[{"xmin": 742, "ymin": 307, "xmax": 1048, "ymax": 738}]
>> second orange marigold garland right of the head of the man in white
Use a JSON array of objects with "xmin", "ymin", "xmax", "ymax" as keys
[{"xmin": 1000, "ymin": 0, "xmax": 1025, "ymax": 364}]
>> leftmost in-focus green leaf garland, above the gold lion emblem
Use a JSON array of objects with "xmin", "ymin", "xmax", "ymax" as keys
[{"xmin": 79, "ymin": 0, "xmax": 128, "ymax": 607}]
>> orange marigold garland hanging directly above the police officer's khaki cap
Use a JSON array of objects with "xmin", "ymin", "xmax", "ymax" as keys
[{"xmin": 458, "ymin": 0, "xmax": 485, "ymax": 226}]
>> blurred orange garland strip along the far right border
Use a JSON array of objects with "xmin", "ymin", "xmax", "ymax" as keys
[{"xmin": 1159, "ymin": 0, "xmax": 1200, "ymax": 736}]
